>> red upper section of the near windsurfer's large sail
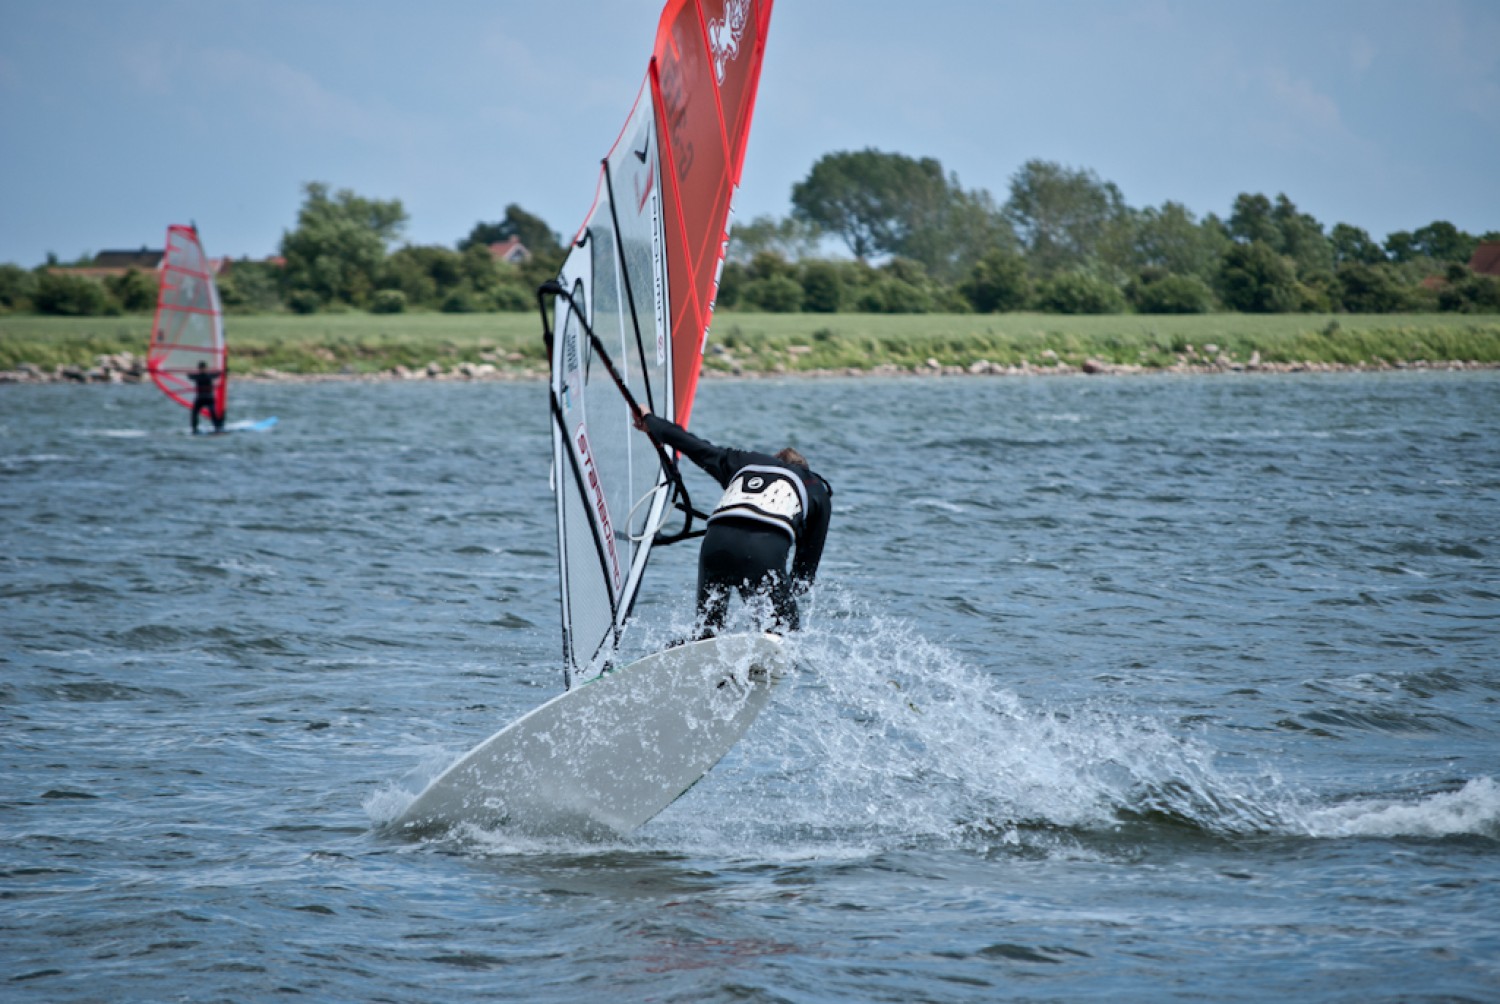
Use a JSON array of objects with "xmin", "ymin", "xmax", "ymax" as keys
[{"xmin": 651, "ymin": 0, "xmax": 771, "ymax": 426}]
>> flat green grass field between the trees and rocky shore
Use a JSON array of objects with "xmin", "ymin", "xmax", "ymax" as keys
[{"xmin": 0, "ymin": 311, "xmax": 1500, "ymax": 374}]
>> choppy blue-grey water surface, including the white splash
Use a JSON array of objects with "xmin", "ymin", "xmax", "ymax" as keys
[{"xmin": 0, "ymin": 374, "xmax": 1500, "ymax": 1001}]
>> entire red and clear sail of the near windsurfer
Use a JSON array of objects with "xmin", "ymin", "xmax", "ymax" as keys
[{"xmin": 549, "ymin": 0, "xmax": 771, "ymax": 674}]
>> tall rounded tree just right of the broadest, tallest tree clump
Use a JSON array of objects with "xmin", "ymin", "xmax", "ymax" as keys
[{"xmin": 1004, "ymin": 161, "xmax": 1127, "ymax": 278}]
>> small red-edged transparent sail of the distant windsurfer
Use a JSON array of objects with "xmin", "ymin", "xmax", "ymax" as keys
[{"xmin": 146, "ymin": 225, "xmax": 230, "ymax": 416}]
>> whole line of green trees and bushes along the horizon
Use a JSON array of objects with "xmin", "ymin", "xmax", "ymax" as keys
[{"xmin": 0, "ymin": 149, "xmax": 1500, "ymax": 315}]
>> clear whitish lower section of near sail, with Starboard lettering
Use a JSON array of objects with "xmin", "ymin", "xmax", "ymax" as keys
[{"xmin": 552, "ymin": 86, "xmax": 674, "ymax": 677}]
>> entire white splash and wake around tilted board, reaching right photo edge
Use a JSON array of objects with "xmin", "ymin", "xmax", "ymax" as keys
[{"xmin": 365, "ymin": 593, "xmax": 1500, "ymax": 860}]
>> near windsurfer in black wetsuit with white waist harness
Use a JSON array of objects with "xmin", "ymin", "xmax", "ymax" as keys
[{"xmin": 645, "ymin": 414, "xmax": 833, "ymax": 633}]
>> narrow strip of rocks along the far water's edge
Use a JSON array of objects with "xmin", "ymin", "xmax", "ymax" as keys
[{"xmin": 0, "ymin": 347, "xmax": 1500, "ymax": 384}]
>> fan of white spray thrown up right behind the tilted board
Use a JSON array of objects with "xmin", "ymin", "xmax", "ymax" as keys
[{"xmin": 641, "ymin": 594, "xmax": 1295, "ymax": 851}]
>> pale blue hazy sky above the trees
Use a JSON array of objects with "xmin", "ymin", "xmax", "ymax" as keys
[{"xmin": 0, "ymin": 0, "xmax": 1500, "ymax": 267}]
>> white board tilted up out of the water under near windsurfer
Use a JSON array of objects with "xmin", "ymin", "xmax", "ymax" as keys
[{"xmin": 392, "ymin": 633, "xmax": 786, "ymax": 839}]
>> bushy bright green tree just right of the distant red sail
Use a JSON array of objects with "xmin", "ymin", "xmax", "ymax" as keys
[{"xmin": 281, "ymin": 182, "xmax": 407, "ymax": 306}]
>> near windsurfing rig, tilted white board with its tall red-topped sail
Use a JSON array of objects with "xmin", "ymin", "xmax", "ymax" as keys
[{"xmin": 395, "ymin": 0, "xmax": 783, "ymax": 836}]
